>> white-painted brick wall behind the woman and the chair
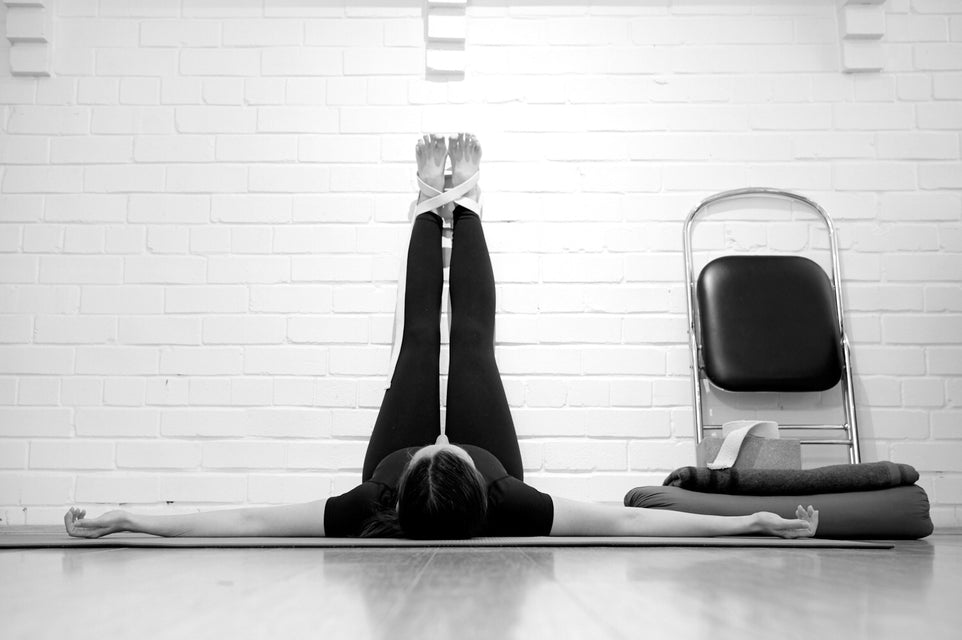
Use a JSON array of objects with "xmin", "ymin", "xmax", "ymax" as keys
[{"xmin": 0, "ymin": 0, "xmax": 962, "ymax": 527}]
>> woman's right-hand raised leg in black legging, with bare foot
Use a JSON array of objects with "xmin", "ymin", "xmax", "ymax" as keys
[{"xmin": 446, "ymin": 134, "xmax": 524, "ymax": 480}]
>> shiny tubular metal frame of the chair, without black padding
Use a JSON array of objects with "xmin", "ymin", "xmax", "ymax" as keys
[{"xmin": 684, "ymin": 187, "xmax": 861, "ymax": 463}]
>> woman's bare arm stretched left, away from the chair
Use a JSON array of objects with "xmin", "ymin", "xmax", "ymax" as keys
[{"xmin": 63, "ymin": 500, "xmax": 327, "ymax": 538}]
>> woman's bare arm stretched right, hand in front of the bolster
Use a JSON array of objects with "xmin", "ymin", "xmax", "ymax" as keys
[{"xmin": 551, "ymin": 496, "xmax": 818, "ymax": 538}]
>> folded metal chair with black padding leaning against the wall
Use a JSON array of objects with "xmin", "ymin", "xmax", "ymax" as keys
[{"xmin": 684, "ymin": 188, "xmax": 861, "ymax": 463}]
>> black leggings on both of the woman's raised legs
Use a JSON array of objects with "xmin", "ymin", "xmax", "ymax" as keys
[{"xmin": 362, "ymin": 207, "xmax": 524, "ymax": 481}]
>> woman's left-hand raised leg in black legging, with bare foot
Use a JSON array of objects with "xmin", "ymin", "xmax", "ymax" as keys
[{"xmin": 362, "ymin": 136, "xmax": 447, "ymax": 480}]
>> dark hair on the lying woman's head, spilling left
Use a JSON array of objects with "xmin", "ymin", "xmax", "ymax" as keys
[{"xmin": 361, "ymin": 450, "xmax": 488, "ymax": 540}]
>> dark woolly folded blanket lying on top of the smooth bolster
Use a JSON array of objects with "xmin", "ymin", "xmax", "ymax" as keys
[{"xmin": 662, "ymin": 462, "xmax": 919, "ymax": 496}]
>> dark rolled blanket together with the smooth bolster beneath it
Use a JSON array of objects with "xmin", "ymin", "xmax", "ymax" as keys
[{"xmin": 625, "ymin": 462, "xmax": 933, "ymax": 539}]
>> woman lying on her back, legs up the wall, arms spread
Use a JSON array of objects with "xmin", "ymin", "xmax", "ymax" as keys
[{"xmin": 64, "ymin": 134, "xmax": 818, "ymax": 539}]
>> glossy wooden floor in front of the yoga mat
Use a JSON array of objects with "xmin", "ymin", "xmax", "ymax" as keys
[{"xmin": 0, "ymin": 535, "xmax": 962, "ymax": 640}]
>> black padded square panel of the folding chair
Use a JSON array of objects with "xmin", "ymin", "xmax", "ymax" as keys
[{"xmin": 697, "ymin": 255, "xmax": 842, "ymax": 391}]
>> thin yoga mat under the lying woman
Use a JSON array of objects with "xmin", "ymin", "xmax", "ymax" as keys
[{"xmin": 0, "ymin": 529, "xmax": 894, "ymax": 549}]
